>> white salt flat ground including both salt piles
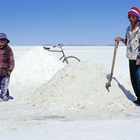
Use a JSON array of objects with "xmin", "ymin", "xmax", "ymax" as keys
[{"xmin": 0, "ymin": 46, "xmax": 140, "ymax": 140}]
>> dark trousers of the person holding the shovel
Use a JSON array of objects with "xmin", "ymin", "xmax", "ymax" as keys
[{"xmin": 129, "ymin": 60, "xmax": 140, "ymax": 99}]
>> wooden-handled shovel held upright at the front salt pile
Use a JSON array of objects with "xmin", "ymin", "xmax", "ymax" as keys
[{"xmin": 105, "ymin": 41, "xmax": 119, "ymax": 92}]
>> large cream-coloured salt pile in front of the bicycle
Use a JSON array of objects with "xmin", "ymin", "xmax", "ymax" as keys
[{"xmin": 26, "ymin": 62, "xmax": 134, "ymax": 114}]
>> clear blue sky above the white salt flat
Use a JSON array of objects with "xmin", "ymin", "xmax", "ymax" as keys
[{"xmin": 0, "ymin": 0, "xmax": 140, "ymax": 45}]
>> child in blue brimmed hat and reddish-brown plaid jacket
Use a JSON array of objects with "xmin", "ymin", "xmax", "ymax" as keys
[{"xmin": 0, "ymin": 33, "xmax": 15, "ymax": 101}]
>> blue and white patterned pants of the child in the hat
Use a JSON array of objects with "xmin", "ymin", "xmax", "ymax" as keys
[{"xmin": 0, "ymin": 76, "xmax": 10, "ymax": 98}]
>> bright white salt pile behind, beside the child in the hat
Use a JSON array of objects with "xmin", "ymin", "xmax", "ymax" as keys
[{"xmin": 11, "ymin": 47, "xmax": 64, "ymax": 95}]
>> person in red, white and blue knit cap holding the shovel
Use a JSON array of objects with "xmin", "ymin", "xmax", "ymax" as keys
[{"xmin": 115, "ymin": 7, "xmax": 140, "ymax": 105}]
